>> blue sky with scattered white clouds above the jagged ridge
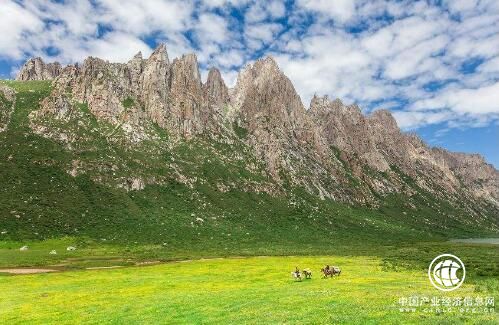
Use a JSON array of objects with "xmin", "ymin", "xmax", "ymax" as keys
[{"xmin": 0, "ymin": 0, "xmax": 499, "ymax": 167}]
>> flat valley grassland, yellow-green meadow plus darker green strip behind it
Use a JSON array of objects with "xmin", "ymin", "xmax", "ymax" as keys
[{"xmin": 0, "ymin": 238, "xmax": 499, "ymax": 324}]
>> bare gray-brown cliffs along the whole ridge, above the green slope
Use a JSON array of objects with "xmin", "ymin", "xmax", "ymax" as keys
[{"xmin": 15, "ymin": 45, "xmax": 499, "ymax": 209}]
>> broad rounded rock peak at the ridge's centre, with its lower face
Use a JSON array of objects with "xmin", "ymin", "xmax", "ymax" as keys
[{"xmin": 231, "ymin": 57, "xmax": 339, "ymax": 197}]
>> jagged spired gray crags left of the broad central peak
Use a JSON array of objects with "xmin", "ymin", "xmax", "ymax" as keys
[{"xmin": 33, "ymin": 44, "xmax": 213, "ymax": 137}]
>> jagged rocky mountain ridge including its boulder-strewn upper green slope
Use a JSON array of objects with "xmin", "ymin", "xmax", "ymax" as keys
[{"xmin": 2, "ymin": 44, "xmax": 499, "ymax": 240}]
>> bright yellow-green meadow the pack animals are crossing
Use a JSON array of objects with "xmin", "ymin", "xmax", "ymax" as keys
[{"xmin": 0, "ymin": 256, "xmax": 499, "ymax": 324}]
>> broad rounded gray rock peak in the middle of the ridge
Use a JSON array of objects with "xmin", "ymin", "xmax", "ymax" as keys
[{"xmin": 231, "ymin": 57, "xmax": 332, "ymax": 184}]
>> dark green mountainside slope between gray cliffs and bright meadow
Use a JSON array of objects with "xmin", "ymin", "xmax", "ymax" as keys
[{"xmin": 0, "ymin": 81, "xmax": 498, "ymax": 256}]
